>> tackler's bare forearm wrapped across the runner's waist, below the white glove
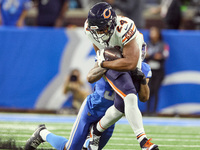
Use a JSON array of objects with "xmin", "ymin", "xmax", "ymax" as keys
[{"xmin": 87, "ymin": 66, "xmax": 107, "ymax": 83}]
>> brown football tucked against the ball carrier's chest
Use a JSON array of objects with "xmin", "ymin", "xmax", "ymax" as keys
[{"xmin": 104, "ymin": 47, "xmax": 123, "ymax": 61}]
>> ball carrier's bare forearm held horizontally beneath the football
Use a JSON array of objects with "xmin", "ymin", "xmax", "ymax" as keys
[{"xmin": 102, "ymin": 58, "xmax": 137, "ymax": 71}]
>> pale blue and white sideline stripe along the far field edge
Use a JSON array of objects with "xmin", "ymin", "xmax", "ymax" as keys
[{"xmin": 0, "ymin": 113, "xmax": 200, "ymax": 126}]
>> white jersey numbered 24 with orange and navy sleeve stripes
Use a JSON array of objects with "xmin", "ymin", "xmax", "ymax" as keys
[{"xmin": 84, "ymin": 16, "xmax": 144, "ymax": 68}]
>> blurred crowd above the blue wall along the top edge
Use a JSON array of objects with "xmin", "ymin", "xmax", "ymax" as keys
[{"xmin": 0, "ymin": 0, "xmax": 200, "ymax": 29}]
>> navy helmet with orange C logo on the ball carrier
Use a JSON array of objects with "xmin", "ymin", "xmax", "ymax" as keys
[{"xmin": 88, "ymin": 2, "xmax": 117, "ymax": 43}]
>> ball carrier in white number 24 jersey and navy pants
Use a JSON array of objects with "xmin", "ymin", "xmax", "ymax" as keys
[{"xmin": 84, "ymin": 2, "xmax": 158, "ymax": 150}]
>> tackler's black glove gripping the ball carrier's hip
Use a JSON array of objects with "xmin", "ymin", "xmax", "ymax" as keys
[{"xmin": 131, "ymin": 68, "xmax": 147, "ymax": 85}]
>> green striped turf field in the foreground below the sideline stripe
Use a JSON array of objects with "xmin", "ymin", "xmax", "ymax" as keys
[{"xmin": 0, "ymin": 118, "xmax": 200, "ymax": 150}]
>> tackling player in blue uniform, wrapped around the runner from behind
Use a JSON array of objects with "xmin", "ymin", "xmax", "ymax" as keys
[{"xmin": 25, "ymin": 60, "xmax": 151, "ymax": 150}]
